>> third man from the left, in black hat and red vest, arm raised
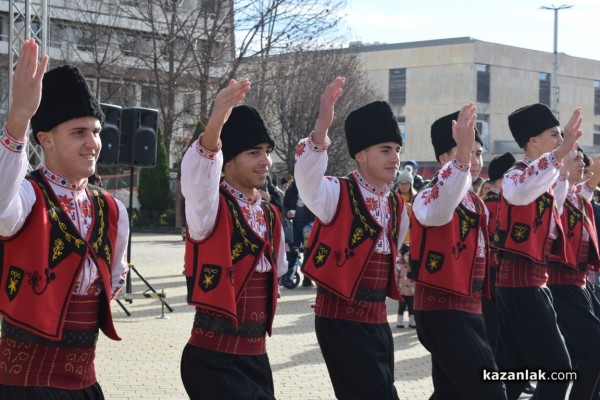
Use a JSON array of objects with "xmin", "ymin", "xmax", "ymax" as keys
[{"xmin": 295, "ymin": 77, "xmax": 408, "ymax": 400}]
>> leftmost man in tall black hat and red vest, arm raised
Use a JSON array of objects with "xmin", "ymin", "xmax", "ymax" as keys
[{"xmin": 0, "ymin": 39, "xmax": 129, "ymax": 400}]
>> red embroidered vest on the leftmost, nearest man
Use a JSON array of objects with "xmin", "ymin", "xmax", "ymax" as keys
[{"xmin": 0, "ymin": 171, "xmax": 120, "ymax": 340}]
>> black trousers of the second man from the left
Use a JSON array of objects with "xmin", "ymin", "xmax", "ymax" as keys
[{"xmin": 181, "ymin": 343, "xmax": 275, "ymax": 400}]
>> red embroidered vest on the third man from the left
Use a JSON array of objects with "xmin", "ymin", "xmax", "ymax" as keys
[{"xmin": 303, "ymin": 176, "xmax": 404, "ymax": 301}]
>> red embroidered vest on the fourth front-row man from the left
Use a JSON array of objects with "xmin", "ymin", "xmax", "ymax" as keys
[{"xmin": 407, "ymin": 192, "xmax": 489, "ymax": 297}]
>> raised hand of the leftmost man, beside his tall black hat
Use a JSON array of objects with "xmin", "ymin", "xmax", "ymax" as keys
[{"xmin": 6, "ymin": 39, "xmax": 48, "ymax": 141}]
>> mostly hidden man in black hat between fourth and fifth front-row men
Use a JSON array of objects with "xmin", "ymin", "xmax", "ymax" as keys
[{"xmin": 481, "ymin": 152, "xmax": 517, "ymax": 353}]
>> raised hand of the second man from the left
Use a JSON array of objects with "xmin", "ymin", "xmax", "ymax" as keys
[{"xmin": 202, "ymin": 79, "xmax": 251, "ymax": 150}]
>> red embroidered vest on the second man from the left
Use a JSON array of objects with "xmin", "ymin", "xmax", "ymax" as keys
[{"xmin": 185, "ymin": 188, "xmax": 281, "ymax": 335}]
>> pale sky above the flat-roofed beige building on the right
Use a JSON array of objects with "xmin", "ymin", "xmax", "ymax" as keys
[{"xmin": 345, "ymin": 0, "xmax": 600, "ymax": 60}]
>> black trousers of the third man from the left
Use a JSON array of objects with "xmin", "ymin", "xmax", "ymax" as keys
[{"xmin": 315, "ymin": 317, "xmax": 398, "ymax": 400}]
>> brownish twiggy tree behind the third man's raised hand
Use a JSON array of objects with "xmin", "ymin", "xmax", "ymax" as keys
[{"xmin": 247, "ymin": 49, "xmax": 381, "ymax": 175}]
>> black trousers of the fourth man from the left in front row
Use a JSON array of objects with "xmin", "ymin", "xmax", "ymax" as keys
[{"xmin": 415, "ymin": 310, "xmax": 506, "ymax": 400}]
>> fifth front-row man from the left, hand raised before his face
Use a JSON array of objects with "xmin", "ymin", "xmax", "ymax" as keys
[{"xmin": 494, "ymin": 103, "xmax": 581, "ymax": 399}]
